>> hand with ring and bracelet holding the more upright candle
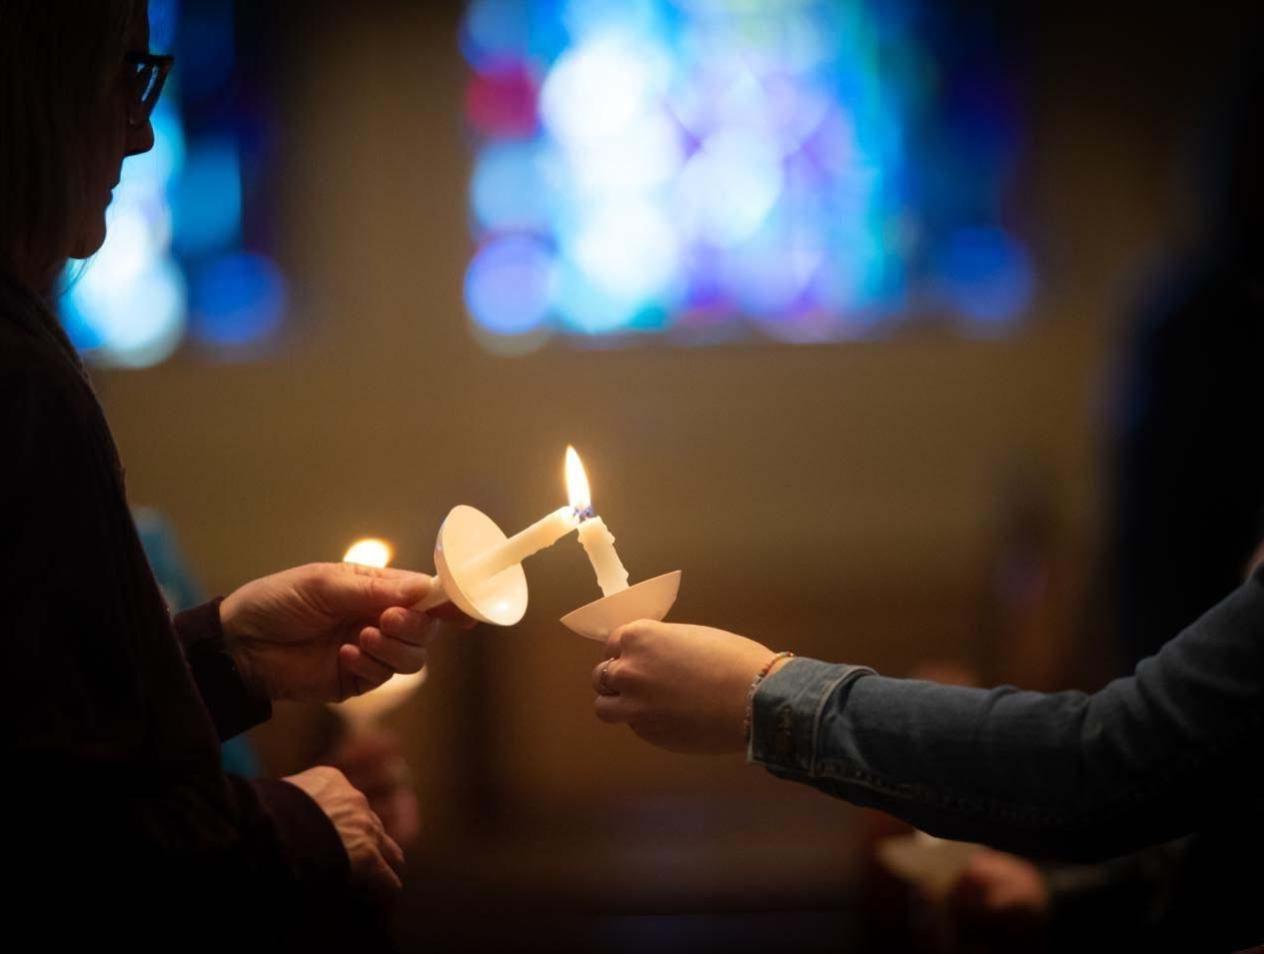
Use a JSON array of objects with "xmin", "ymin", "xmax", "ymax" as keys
[{"xmin": 593, "ymin": 620, "xmax": 774, "ymax": 753}]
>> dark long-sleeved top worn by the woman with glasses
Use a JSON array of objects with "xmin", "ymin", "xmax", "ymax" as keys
[{"xmin": 0, "ymin": 275, "xmax": 349, "ymax": 940}]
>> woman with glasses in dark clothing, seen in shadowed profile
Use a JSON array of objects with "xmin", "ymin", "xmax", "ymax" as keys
[{"xmin": 0, "ymin": 0, "xmax": 447, "ymax": 946}]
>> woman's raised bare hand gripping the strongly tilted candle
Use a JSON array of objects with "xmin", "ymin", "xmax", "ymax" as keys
[{"xmin": 220, "ymin": 564, "xmax": 452, "ymax": 703}]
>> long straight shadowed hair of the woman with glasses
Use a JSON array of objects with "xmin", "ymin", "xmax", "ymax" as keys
[{"xmin": 0, "ymin": 0, "xmax": 138, "ymax": 293}]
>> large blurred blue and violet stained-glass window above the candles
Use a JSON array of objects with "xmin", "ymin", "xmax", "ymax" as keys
[{"xmin": 461, "ymin": 0, "xmax": 1034, "ymax": 343}]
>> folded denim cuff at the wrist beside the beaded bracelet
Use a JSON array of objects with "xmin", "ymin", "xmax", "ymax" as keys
[{"xmin": 746, "ymin": 658, "xmax": 875, "ymax": 778}]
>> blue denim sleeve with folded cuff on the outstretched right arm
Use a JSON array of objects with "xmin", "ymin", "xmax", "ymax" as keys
[{"xmin": 748, "ymin": 570, "xmax": 1264, "ymax": 860}]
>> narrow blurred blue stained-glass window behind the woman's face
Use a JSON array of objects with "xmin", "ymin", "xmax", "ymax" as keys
[{"xmin": 61, "ymin": 0, "xmax": 287, "ymax": 368}]
